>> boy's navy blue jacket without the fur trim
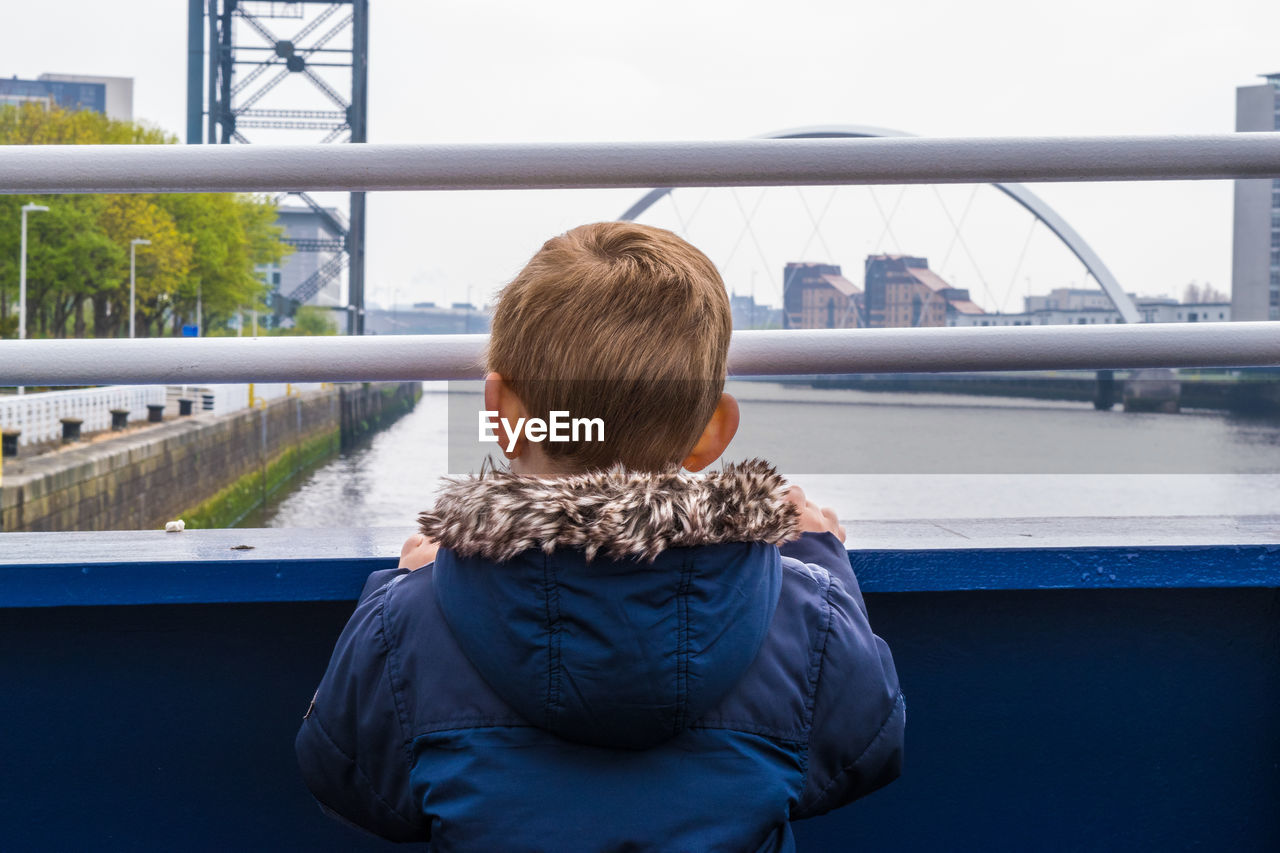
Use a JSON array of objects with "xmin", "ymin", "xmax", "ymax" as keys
[{"xmin": 296, "ymin": 533, "xmax": 905, "ymax": 852}]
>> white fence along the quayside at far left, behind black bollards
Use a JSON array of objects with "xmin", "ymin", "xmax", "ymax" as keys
[{"xmin": 0, "ymin": 383, "xmax": 165, "ymax": 444}]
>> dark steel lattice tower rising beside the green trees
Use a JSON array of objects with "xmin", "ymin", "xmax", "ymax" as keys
[{"xmin": 187, "ymin": 0, "xmax": 369, "ymax": 334}]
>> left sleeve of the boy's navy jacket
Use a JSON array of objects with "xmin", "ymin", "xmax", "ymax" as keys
[{"xmin": 294, "ymin": 571, "xmax": 430, "ymax": 841}]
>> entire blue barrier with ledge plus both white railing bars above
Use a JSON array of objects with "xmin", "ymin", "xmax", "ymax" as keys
[{"xmin": 0, "ymin": 133, "xmax": 1280, "ymax": 852}]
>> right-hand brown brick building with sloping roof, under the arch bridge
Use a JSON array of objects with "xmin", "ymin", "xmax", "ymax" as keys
[{"xmin": 864, "ymin": 255, "xmax": 986, "ymax": 328}]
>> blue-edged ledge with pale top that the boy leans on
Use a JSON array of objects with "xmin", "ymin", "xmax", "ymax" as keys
[{"xmin": 0, "ymin": 516, "xmax": 1280, "ymax": 607}]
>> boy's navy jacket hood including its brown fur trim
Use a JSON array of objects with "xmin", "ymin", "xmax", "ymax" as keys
[{"xmin": 419, "ymin": 460, "xmax": 797, "ymax": 749}]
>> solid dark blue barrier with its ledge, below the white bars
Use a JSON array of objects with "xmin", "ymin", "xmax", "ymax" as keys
[{"xmin": 0, "ymin": 517, "xmax": 1280, "ymax": 853}]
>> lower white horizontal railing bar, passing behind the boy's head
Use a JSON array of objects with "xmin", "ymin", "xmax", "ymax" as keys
[{"xmin": 0, "ymin": 321, "xmax": 1280, "ymax": 386}]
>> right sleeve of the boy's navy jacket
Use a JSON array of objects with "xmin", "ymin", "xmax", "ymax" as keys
[{"xmin": 782, "ymin": 533, "xmax": 906, "ymax": 820}]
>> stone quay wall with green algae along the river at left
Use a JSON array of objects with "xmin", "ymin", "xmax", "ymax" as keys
[{"xmin": 0, "ymin": 383, "xmax": 421, "ymax": 532}]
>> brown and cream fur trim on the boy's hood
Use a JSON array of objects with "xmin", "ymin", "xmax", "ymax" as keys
[{"xmin": 419, "ymin": 460, "xmax": 799, "ymax": 562}]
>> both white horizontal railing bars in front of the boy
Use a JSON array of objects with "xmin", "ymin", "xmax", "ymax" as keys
[{"xmin": 0, "ymin": 133, "xmax": 1280, "ymax": 384}]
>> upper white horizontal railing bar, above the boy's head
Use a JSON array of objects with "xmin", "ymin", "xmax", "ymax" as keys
[{"xmin": 0, "ymin": 133, "xmax": 1280, "ymax": 193}]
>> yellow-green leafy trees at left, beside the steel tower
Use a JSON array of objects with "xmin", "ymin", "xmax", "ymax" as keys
[{"xmin": 0, "ymin": 104, "xmax": 291, "ymax": 337}]
